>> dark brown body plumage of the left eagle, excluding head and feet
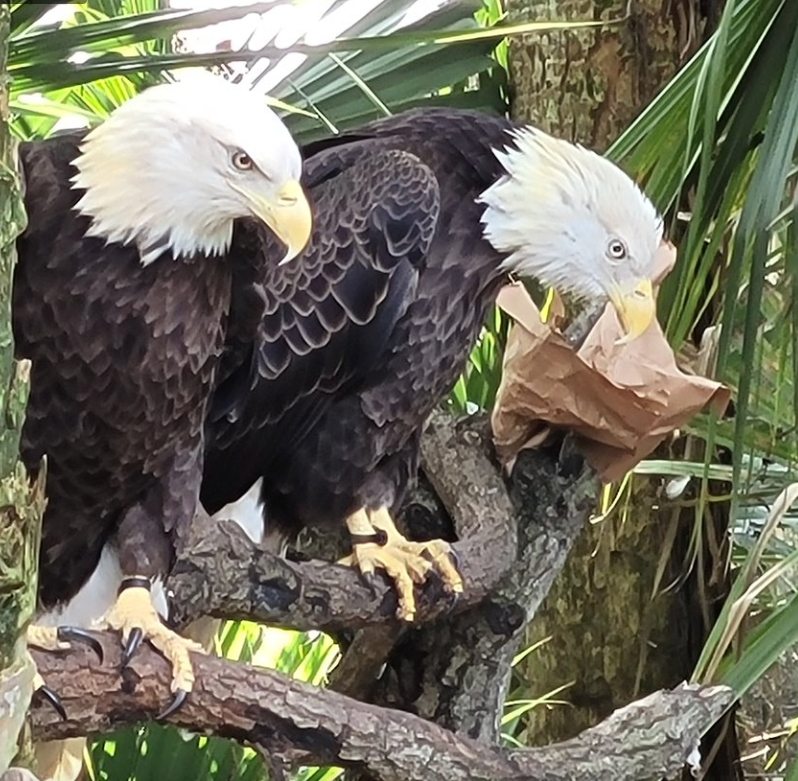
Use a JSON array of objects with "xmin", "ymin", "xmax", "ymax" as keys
[{"xmin": 13, "ymin": 137, "xmax": 230, "ymax": 607}]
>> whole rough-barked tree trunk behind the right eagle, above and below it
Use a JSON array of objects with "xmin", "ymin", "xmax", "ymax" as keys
[{"xmin": 507, "ymin": 0, "xmax": 732, "ymax": 779}]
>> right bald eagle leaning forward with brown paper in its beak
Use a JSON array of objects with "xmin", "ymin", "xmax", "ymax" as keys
[{"xmin": 201, "ymin": 109, "xmax": 662, "ymax": 621}]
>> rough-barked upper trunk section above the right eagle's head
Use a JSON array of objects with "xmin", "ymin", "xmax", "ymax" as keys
[{"xmin": 507, "ymin": 0, "xmax": 721, "ymax": 150}]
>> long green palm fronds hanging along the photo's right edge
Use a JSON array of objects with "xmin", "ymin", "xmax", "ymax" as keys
[{"xmin": 610, "ymin": 0, "xmax": 798, "ymax": 760}]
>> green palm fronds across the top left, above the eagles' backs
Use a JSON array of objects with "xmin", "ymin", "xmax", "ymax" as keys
[{"xmin": 9, "ymin": 0, "xmax": 612, "ymax": 135}]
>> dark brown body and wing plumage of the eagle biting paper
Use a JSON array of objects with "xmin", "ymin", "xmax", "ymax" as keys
[{"xmin": 202, "ymin": 110, "xmax": 512, "ymax": 531}]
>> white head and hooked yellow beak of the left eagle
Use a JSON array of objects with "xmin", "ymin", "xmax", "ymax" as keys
[{"xmin": 72, "ymin": 75, "xmax": 311, "ymax": 265}]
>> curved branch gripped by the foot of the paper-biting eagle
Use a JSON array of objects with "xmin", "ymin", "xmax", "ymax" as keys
[{"xmin": 168, "ymin": 417, "xmax": 517, "ymax": 632}]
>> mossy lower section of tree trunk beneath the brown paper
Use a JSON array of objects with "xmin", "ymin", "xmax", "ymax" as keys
[{"xmin": 521, "ymin": 476, "xmax": 690, "ymax": 743}]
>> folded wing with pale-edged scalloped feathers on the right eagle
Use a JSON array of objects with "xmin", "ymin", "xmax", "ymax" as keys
[{"xmin": 202, "ymin": 151, "xmax": 439, "ymax": 512}]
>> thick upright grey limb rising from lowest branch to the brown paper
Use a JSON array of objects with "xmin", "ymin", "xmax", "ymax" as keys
[{"xmin": 375, "ymin": 436, "xmax": 599, "ymax": 742}]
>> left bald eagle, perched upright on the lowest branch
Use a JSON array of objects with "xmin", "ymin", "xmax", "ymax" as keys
[{"xmin": 18, "ymin": 78, "xmax": 310, "ymax": 707}]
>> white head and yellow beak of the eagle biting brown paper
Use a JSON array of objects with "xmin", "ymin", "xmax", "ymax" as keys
[{"xmin": 479, "ymin": 127, "xmax": 662, "ymax": 338}]
